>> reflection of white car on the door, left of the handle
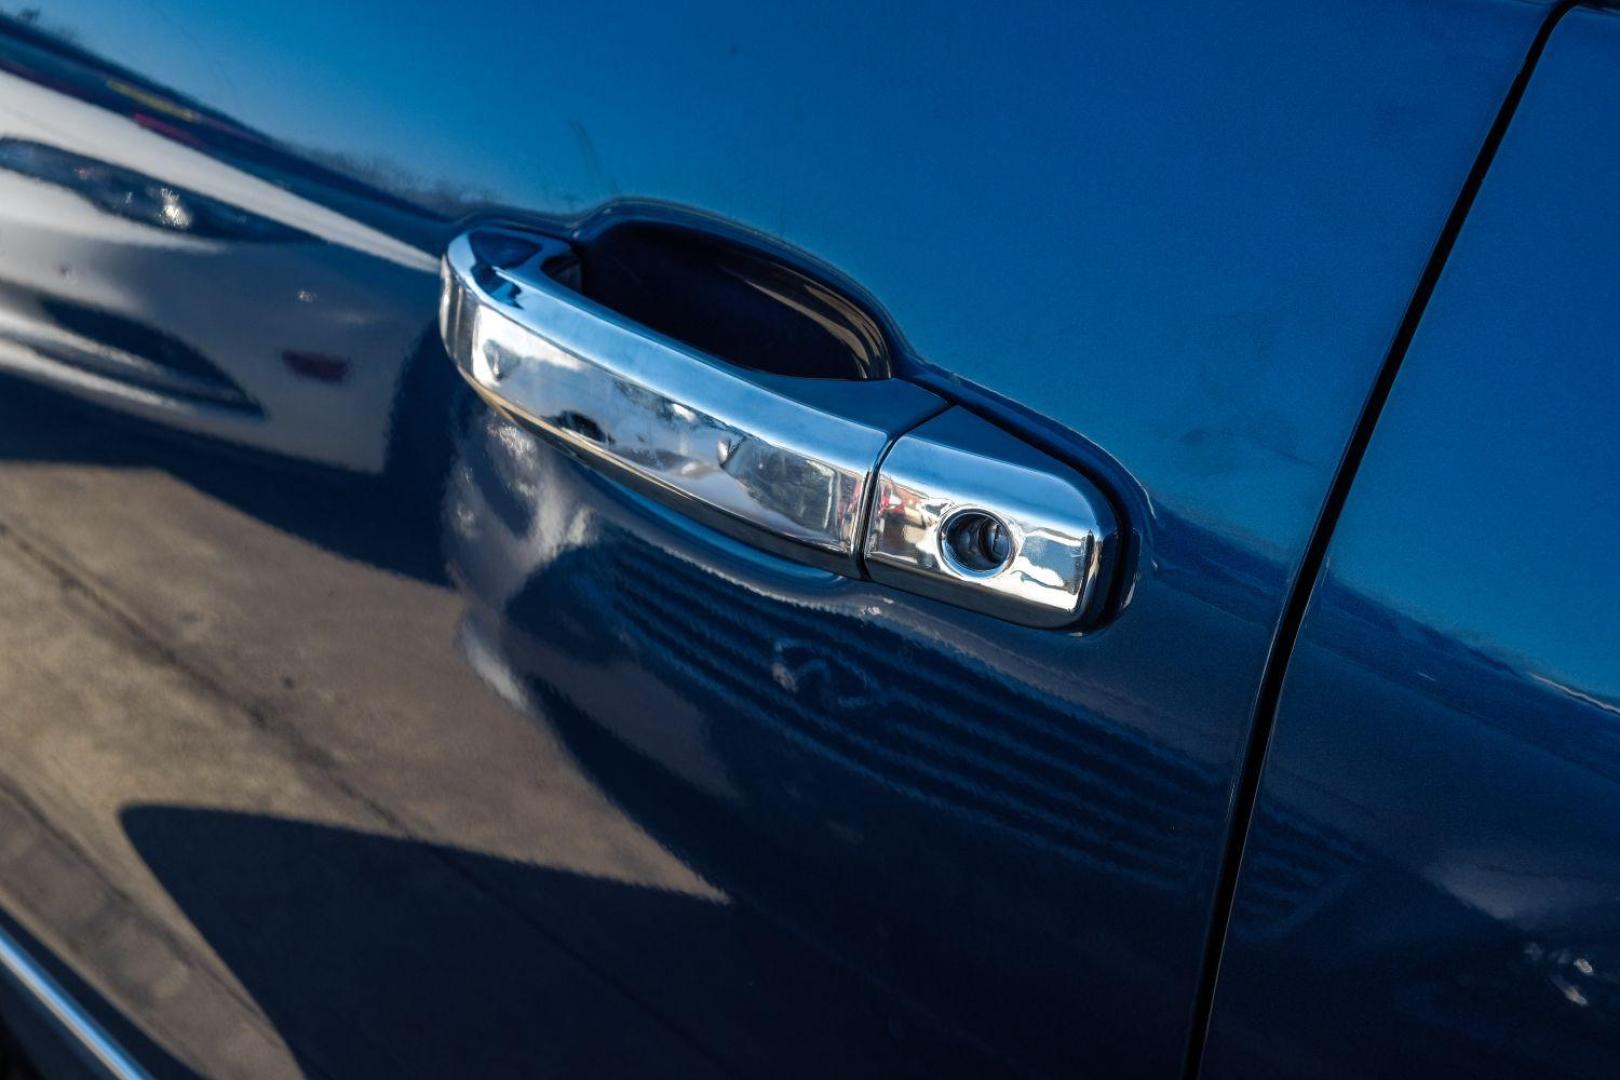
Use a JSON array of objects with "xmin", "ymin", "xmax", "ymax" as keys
[{"xmin": 0, "ymin": 74, "xmax": 437, "ymax": 473}]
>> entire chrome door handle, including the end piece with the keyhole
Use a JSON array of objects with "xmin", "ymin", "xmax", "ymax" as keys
[{"xmin": 439, "ymin": 228, "xmax": 1118, "ymax": 627}]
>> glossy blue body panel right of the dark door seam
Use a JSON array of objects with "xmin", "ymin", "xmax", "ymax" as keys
[{"xmin": 1204, "ymin": 11, "xmax": 1620, "ymax": 1077}]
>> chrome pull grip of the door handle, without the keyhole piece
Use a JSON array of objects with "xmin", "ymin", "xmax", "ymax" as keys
[{"xmin": 439, "ymin": 228, "xmax": 944, "ymax": 576}]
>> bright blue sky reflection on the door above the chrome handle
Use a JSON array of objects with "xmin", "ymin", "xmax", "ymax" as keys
[{"xmin": 49, "ymin": 0, "xmax": 1541, "ymax": 552}]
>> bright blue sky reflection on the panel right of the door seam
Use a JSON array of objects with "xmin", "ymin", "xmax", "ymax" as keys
[{"xmin": 1332, "ymin": 15, "xmax": 1620, "ymax": 701}]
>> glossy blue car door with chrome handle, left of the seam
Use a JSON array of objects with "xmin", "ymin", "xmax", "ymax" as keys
[{"xmin": 0, "ymin": 0, "xmax": 1550, "ymax": 1077}]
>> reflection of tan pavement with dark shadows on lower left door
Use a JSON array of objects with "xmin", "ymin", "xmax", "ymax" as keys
[{"xmin": 0, "ymin": 384, "xmax": 959, "ymax": 1075}]
